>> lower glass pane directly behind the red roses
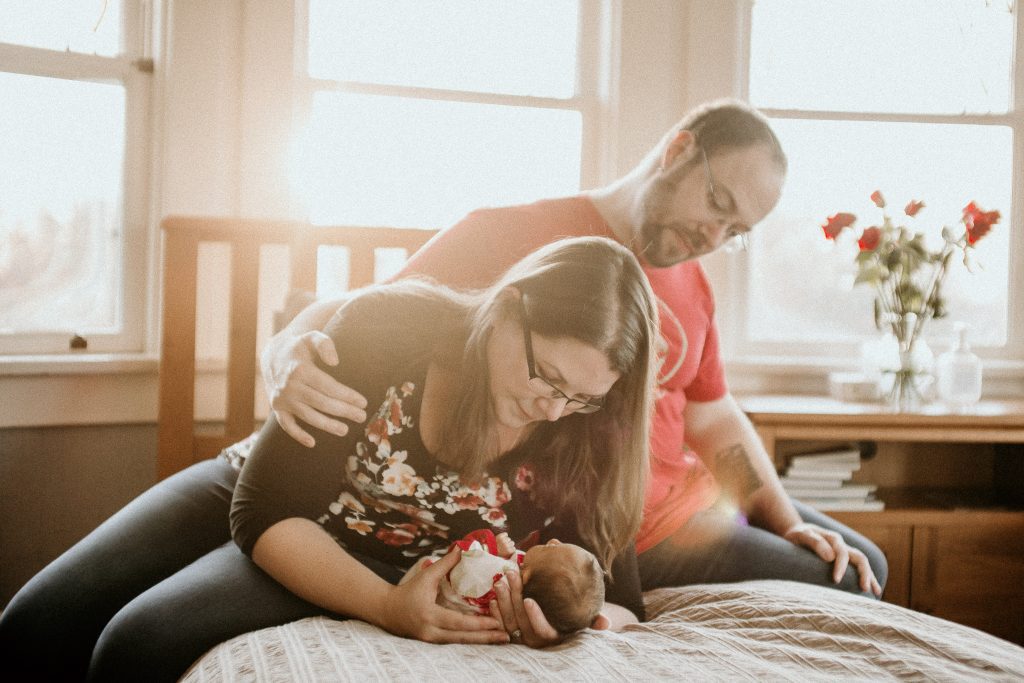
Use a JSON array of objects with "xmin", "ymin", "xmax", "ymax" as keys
[{"xmin": 748, "ymin": 120, "xmax": 1014, "ymax": 346}]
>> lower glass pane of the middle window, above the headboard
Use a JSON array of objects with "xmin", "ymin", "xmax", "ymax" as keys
[{"xmin": 292, "ymin": 92, "xmax": 582, "ymax": 227}]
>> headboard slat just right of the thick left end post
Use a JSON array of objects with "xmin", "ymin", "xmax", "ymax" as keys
[{"xmin": 224, "ymin": 242, "xmax": 260, "ymax": 438}]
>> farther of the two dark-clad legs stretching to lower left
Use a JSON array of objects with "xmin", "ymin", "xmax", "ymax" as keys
[{"xmin": 0, "ymin": 459, "xmax": 238, "ymax": 680}]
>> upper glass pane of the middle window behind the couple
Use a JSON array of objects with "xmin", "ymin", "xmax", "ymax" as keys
[{"xmin": 309, "ymin": 0, "xmax": 579, "ymax": 98}]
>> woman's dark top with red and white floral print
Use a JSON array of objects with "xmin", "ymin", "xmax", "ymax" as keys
[{"xmin": 231, "ymin": 288, "xmax": 552, "ymax": 567}]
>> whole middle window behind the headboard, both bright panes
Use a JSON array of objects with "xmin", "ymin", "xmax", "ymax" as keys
[{"xmin": 291, "ymin": 0, "xmax": 597, "ymax": 236}]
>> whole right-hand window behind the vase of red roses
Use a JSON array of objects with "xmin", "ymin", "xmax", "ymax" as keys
[{"xmin": 732, "ymin": 0, "xmax": 1024, "ymax": 366}]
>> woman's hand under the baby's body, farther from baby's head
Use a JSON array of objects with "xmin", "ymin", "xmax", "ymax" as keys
[{"xmin": 377, "ymin": 548, "xmax": 509, "ymax": 643}]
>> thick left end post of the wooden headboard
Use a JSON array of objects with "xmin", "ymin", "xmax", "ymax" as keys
[{"xmin": 157, "ymin": 228, "xmax": 199, "ymax": 479}]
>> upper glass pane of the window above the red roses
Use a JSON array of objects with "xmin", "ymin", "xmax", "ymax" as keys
[{"xmin": 750, "ymin": 0, "xmax": 1015, "ymax": 114}]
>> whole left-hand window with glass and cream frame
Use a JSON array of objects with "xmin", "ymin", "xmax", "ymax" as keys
[{"xmin": 0, "ymin": 0, "xmax": 148, "ymax": 354}]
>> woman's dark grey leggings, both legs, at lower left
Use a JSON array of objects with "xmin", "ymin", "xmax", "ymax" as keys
[{"xmin": 0, "ymin": 458, "xmax": 401, "ymax": 681}]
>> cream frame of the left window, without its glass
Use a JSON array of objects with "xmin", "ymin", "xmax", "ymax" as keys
[{"xmin": 0, "ymin": 0, "xmax": 153, "ymax": 358}]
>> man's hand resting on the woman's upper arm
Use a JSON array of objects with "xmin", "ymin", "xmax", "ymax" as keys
[{"xmin": 263, "ymin": 332, "xmax": 367, "ymax": 447}]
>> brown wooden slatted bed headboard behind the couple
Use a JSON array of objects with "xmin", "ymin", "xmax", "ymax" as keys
[{"xmin": 157, "ymin": 216, "xmax": 435, "ymax": 479}]
